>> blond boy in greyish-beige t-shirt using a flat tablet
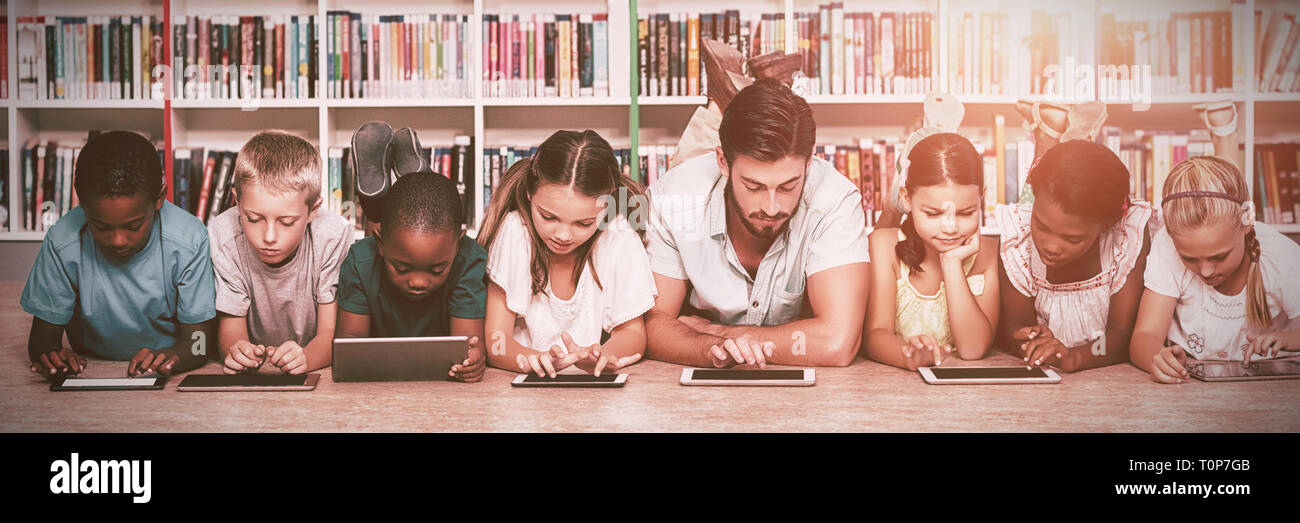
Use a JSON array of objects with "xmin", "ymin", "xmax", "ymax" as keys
[{"xmin": 208, "ymin": 131, "xmax": 354, "ymax": 373}]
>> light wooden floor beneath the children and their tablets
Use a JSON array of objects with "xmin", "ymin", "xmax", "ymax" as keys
[{"xmin": 0, "ymin": 282, "xmax": 1300, "ymax": 432}]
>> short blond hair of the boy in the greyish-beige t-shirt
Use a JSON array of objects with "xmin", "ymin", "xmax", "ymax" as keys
[{"xmin": 233, "ymin": 130, "xmax": 321, "ymax": 207}]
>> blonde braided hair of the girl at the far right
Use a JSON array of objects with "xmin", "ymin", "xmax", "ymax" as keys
[{"xmin": 1161, "ymin": 156, "xmax": 1270, "ymax": 329}]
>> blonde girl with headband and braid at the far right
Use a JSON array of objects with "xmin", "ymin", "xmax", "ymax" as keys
[{"xmin": 1130, "ymin": 156, "xmax": 1300, "ymax": 382}]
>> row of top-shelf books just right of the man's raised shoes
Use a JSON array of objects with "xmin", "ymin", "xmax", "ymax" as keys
[{"xmin": 796, "ymin": 1, "xmax": 939, "ymax": 95}]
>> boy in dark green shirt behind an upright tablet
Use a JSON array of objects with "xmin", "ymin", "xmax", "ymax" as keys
[{"xmin": 335, "ymin": 170, "xmax": 488, "ymax": 381}]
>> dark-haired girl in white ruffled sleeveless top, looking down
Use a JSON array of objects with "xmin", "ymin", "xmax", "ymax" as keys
[{"xmin": 996, "ymin": 139, "xmax": 1152, "ymax": 372}]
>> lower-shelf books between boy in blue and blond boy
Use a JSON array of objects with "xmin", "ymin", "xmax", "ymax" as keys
[{"xmin": 172, "ymin": 147, "xmax": 238, "ymax": 222}]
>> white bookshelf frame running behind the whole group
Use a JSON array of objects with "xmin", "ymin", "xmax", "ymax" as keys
[{"xmin": 0, "ymin": 0, "xmax": 1300, "ymax": 242}]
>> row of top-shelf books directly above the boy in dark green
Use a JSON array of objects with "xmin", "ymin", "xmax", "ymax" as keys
[{"xmin": 325, "ymin": 10, "xmax": 473, "ymax": 98}]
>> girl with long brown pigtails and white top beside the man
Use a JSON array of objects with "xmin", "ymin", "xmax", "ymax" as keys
[{"xmin": 478, "ymin": 130, "xmax": 657, "ymax": 377}]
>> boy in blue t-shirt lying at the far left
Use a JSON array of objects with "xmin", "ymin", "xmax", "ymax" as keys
[{"xmin": 21, "ymin": 131, "xmax": 216, "ymax": 379}]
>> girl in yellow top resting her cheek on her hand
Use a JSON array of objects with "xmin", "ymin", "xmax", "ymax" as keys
[{"xmin": 863, "ymin": 133, "xmax": 998, "ymax": 371}]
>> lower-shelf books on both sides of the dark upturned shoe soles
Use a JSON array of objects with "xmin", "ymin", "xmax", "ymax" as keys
[{"xmin": 324, "ymin": 135, "xmax": 475, "ymax": 229}]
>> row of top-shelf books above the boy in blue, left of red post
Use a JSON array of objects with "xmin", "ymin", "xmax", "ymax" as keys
[{"xmin": 15, "ymin": 16, "xmax": 164, "ymax": 100}]
